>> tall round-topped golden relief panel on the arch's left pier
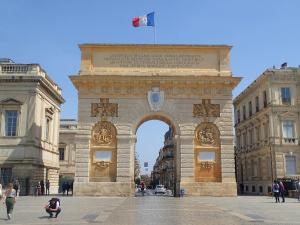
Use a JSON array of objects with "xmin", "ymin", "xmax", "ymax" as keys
[{"xmin": 89, "ymin": 121, "xmax": 117, "ymax": 182}]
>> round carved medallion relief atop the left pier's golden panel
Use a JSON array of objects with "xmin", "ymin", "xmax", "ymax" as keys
[{"xmin": 92, "ymin": 121, "xmax": 116, "ymax": 146}]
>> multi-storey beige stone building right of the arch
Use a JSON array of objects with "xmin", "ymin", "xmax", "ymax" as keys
[{"xmin": 234, "ymin": 65, "xmax": 300, "ymax": 194}]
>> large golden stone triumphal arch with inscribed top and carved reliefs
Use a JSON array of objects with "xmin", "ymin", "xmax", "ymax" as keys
[{"xmin": 70, "ymin": 44, "xmax": 240, "ymax": 196}]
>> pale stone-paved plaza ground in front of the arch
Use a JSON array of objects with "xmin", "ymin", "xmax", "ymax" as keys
[{"xmin": 0, "ymin": 196, "xmax": 300, "ymax": 225}]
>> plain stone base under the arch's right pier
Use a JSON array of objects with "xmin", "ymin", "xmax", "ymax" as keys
[{"xmin": 180, "ymin": 182, "xmax": 237, "ymax": 197}]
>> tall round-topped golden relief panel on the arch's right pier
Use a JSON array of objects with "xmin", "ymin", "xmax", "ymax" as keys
[{"xmin": 194, "ymin": 122, "xmax": 221, "ymax": 182}]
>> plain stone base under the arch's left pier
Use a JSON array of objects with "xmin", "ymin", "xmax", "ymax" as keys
[{"xmin": 74, "ymin": 182, "xmax": 134, "ymax": 196}]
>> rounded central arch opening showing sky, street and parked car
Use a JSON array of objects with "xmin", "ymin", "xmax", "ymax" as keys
[{"xmin": 134, "ymin": 115, "xmax": 176, "ymax": 196}]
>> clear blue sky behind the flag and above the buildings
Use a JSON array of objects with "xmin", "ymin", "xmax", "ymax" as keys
[{"xmin": 0, "ymin": 0, "xmax": 300, "ymax": 172}]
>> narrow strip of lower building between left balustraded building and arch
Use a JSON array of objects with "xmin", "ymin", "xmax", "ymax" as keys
[{"xmin": 58, "ymin": 119, "xmax": 77, "ymax": 180}]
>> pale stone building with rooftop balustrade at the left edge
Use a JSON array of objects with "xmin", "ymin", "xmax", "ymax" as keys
[{"xmin": 0, "ymin": 59, "xmax": 64, "ymax": 195}]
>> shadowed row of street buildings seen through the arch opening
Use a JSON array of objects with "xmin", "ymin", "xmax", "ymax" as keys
[{"xmin": 151, "ymin": 127, "xmax": 175, "ymax": 190}]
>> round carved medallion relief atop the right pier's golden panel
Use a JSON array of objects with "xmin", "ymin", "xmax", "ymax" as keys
[{"xmin": 195, "ymin": 122, "xmax": 220, "ymax": 147}]
